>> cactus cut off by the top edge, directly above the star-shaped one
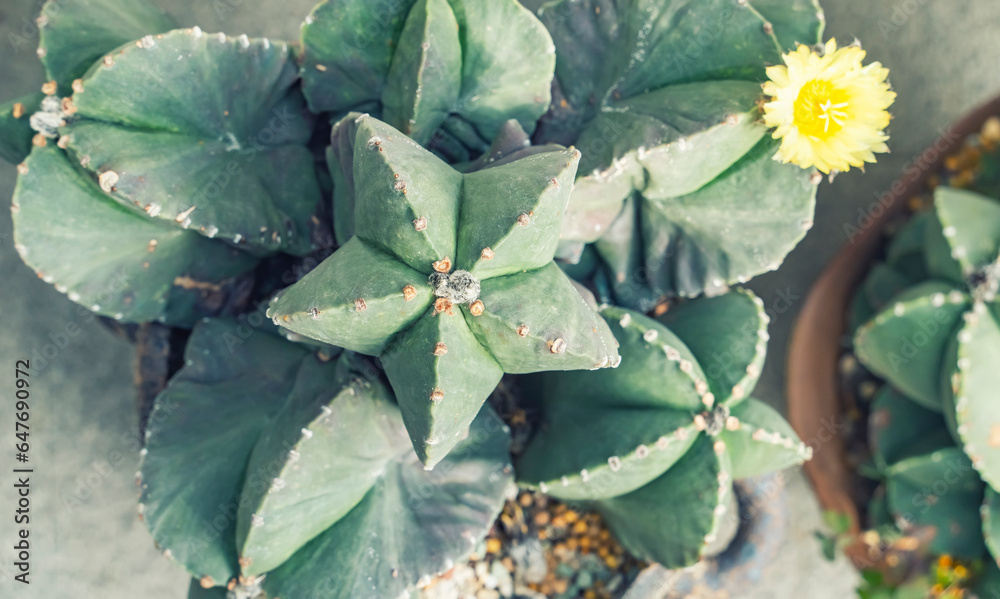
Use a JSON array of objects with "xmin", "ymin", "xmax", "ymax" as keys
[{"xmin": 302, "ymin": 0, "xmax": 555, "ymax": 160}]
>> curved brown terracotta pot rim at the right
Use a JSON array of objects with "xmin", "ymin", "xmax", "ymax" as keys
[{"xmin": 786, "ymin": 91, "xmax": 1000, "ymax": 568}]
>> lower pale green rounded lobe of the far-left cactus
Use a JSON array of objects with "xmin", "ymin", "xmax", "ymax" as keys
[{"xmin": 12, "ymin": 144, "xmax": 255, "ymax": 326}]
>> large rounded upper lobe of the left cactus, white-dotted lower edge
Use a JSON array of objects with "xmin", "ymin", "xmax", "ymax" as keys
[{"xmin": 63, "ymin": 29, "xmax": 320, "ymax": 254}]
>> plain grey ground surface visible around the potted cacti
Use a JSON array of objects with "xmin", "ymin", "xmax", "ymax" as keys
[{"xmin": 0, "ymin": 0, "xmax": 1000, "ymax": 599}]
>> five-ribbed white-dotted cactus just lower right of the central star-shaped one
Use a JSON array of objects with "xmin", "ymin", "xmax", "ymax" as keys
[{"xmin": 517, "ymin": 291, "xmax": 811, "ymax": 568}]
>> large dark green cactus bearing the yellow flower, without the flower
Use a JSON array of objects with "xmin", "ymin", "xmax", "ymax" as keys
[{"xmin": 525, "ymin": 0, "xmax": 823, "ymax": 310}]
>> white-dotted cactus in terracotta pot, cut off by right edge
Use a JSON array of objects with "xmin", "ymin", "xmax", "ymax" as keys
[{"xmin": 854, "ymin": 187, "xmax": 1000, "ymax": 488}]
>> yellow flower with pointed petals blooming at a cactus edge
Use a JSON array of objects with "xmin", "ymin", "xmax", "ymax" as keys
[{"xmin": 764, "ymin": 40, "xmax": 896, "ymax": 174}]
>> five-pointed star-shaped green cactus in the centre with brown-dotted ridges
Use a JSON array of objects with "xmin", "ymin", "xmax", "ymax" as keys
[{"xmin": 269, "ymin": 116, "xmax": 619, "ymax": 467}]
